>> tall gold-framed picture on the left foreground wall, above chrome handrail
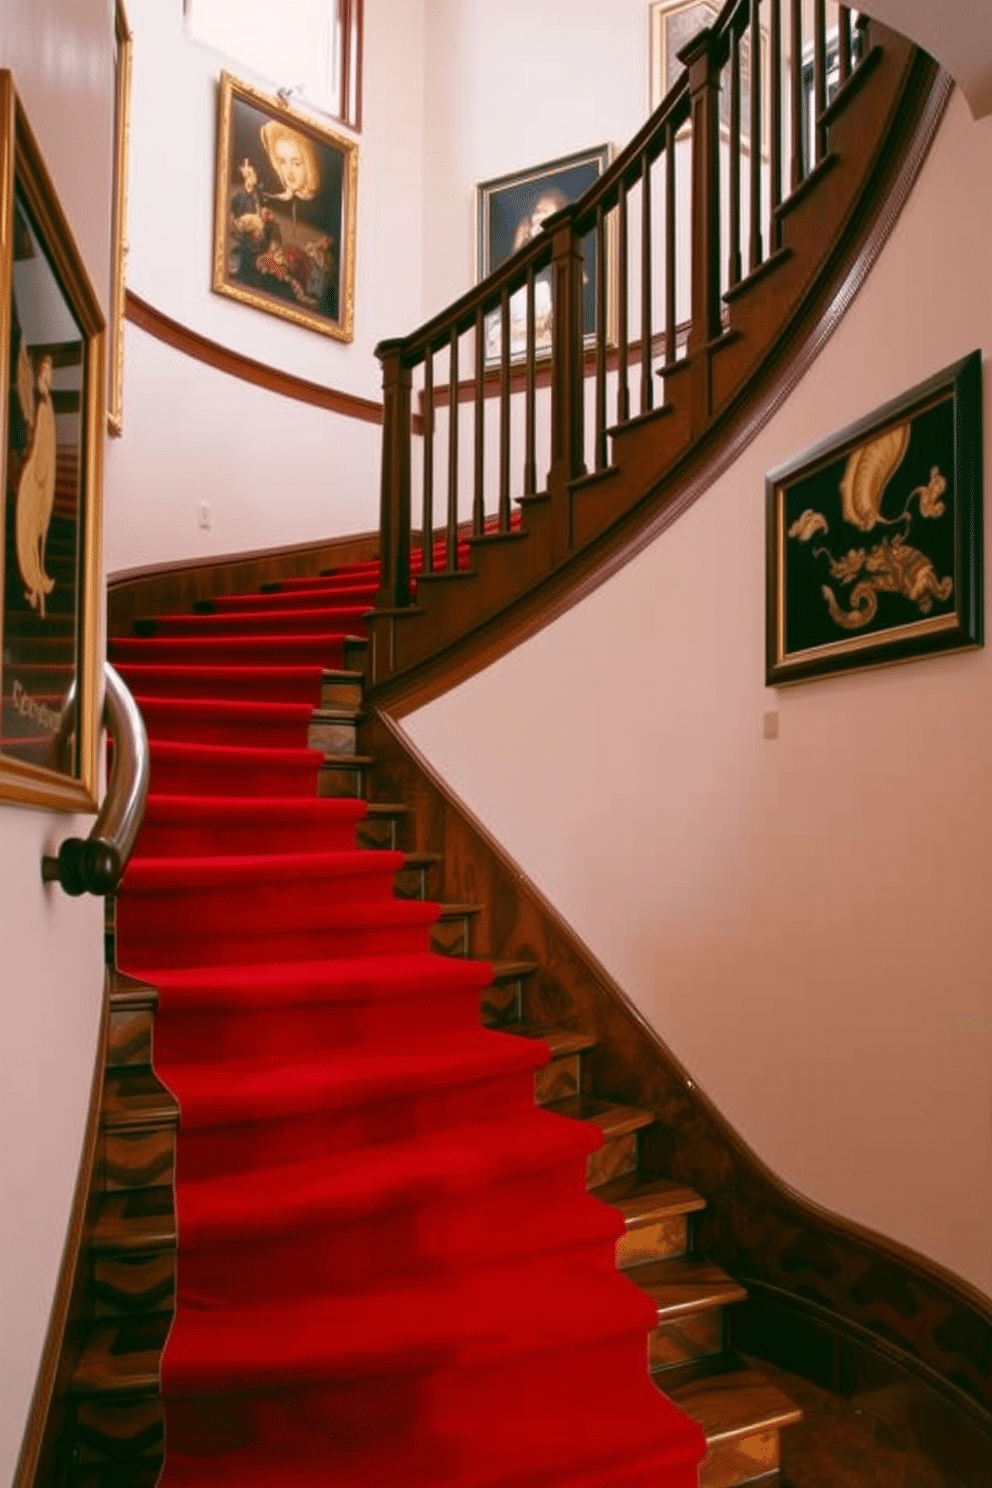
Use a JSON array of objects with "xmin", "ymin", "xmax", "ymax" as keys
[{"xmin": 0, "ymin": 71, "xmax": 106, "ymax": 811}]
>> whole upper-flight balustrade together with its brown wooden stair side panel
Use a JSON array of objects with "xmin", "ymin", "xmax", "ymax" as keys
[{"xmin": 370, "ymin": 0, "xmax": 946, "ymax": 701}]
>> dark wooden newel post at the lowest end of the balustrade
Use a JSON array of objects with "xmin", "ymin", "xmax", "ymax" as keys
[{"xmin": 375, "ymin": 341, "xmax": 412, "ymax": 610}]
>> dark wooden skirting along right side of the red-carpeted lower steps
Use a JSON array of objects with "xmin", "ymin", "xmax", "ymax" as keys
[{"xmin": 363, "ymin": 707, "xmax": 992, "ymax": 1431}]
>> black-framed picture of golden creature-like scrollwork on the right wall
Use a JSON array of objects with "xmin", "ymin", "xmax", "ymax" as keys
[{"xmin": 764, "ymin": 351, "xmax": 983, "ymax": 686}]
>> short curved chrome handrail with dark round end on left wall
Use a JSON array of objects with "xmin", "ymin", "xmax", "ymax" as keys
[{"xmin": 42, "ymin": 662, "xmax": 150, "ymax": 896}]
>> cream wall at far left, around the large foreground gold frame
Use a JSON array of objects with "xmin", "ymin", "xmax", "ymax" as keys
[{"xmin": 0, "ymin": 0, "xmax": 113, "ymax": 1484}]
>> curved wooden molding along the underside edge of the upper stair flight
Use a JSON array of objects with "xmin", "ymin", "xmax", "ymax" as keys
[{"xmin": 369, "ymin": 54, "xmax": 953, "ymax": 717}]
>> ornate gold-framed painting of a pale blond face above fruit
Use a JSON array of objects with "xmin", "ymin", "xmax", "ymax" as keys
[{"xmin": 213, "ymin": 73, "xmax": 358, "ymax": 341}]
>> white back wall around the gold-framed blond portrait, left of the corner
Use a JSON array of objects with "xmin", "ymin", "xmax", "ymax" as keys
[{"xmin": 107, "ymin": 0, "xmax": 424, "ymax": 573}]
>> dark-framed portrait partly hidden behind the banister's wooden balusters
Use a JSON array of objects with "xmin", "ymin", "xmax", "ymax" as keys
[{"xmin": 476, "ymin": 144, "xmax": 616, "ymax": 365}]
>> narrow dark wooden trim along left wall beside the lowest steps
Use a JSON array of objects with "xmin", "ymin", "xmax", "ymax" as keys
[{"xmin": 12, "ymin": 967, "xmax": 110, "ymax": 1488}]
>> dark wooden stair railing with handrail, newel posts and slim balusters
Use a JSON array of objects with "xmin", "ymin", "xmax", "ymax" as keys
[{"xmin": 376, "ymin": 0, "xmax": 864, "ymax": 612}]
